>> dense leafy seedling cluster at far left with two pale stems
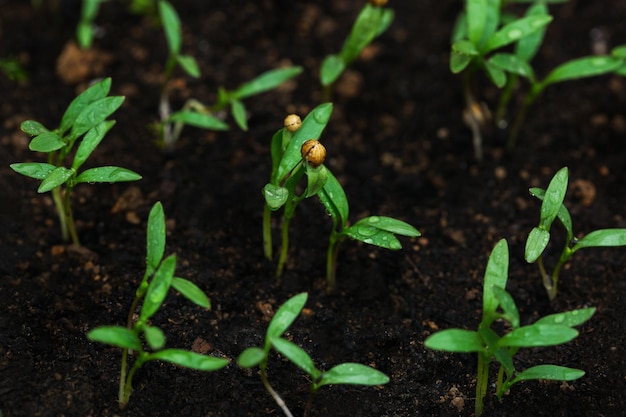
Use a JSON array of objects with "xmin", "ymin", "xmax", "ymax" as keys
[{"xmin": 11, "ymin": 78, "xmax": 141, "ymax": 245}]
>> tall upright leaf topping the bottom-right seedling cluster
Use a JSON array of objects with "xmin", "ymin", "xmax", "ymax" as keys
[{"xmin": 483, "ymin": 239, "xmax": 509, "ymax": 318}]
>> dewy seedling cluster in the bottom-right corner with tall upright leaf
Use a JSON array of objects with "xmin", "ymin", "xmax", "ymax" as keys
[{"xmin": 424, "ymin": 239, "xmax": 595, "ymax": 416}]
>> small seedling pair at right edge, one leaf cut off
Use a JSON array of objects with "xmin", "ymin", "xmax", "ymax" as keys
[{"xmin": 524, "ymin": 167, "xmax": 626, "ymax": 300}]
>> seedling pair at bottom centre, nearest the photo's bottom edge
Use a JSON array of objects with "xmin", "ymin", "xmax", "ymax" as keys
[{"xmin": 237, "ymin": 293, "xmax": 389, "ymax": 417}]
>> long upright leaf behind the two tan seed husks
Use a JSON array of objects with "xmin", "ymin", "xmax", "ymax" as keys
[{"xmin": 271, "ymin": 103, "xmax": 333, "ymax": 184}]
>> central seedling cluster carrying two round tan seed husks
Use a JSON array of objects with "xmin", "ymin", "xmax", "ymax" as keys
[{"xmin": 263, "ymin": 103, "xmax": 420, "ymax": 290}]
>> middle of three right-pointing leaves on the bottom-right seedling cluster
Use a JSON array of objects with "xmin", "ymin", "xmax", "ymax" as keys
[{"xmin": 497, "ymin": 323, "xmax": 578, "ymax": 347}]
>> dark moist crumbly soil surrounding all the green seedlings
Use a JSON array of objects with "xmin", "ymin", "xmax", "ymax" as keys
[{"xmin": 0, "ymin": 0, "xmax": 626, "ymax": 417}]
